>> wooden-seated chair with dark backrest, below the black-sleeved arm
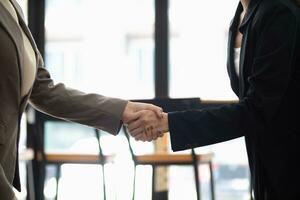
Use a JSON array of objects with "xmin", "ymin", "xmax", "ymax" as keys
[{"xmin": 123, "ymin": 98, "xmax": 217, "ymax": 200}]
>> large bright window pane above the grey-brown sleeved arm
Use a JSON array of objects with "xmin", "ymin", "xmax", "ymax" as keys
[{"xmin": 45, "ymin": 0, "xmax": 154, "ymax": 99}]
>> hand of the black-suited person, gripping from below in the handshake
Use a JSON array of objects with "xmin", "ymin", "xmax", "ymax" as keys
[{"xmin": 128, "ymin": 110, "xmax": 169, "ymax": 142}]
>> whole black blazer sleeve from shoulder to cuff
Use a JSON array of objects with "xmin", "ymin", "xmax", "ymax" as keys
[{"xmin": 169, "ymin": 6, "xmax": 299, "ymax": 151}]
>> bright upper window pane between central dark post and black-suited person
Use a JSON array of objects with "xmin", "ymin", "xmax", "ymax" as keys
[{"xmin": 169, "ymin": 0, "xmax": 238, "ymax": 100}]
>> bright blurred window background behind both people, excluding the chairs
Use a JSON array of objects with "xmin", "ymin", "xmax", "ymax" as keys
[{"xmin": 17, "ymin": 0, "xmax": 250, "ymax": 200}]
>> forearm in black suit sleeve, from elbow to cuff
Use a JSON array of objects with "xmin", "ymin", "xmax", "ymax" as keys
[{"xmin": 168, "ymin": 104, "xmax": 248, "ymax": 151}]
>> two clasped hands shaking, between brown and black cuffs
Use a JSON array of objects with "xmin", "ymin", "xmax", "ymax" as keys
[{"xmin": 122, "ymin": 102, "xmax": 169, "ymax": 142}]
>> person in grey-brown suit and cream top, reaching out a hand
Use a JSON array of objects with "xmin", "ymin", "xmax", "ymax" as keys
[{"xmin": 0, "ymin": 0, "xmax": 162, "ymax": 200}]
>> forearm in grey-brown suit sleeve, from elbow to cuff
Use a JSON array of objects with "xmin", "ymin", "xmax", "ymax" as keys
[{"xmin": 31, "ymin": 91, "xmax": 127, "ymax": 134}]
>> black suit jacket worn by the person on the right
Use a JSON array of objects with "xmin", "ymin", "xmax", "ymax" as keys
[{"xmin": 169, "ymin": 0, "xmax": 300, "ymax": 200}]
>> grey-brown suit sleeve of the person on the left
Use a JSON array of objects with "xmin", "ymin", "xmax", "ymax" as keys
[{"xmin": 30, "ymin": 52, "xmax": 127, "ymax": 135}]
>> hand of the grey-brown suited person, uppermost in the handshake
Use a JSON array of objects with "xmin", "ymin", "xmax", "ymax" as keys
[{"xmin": 122, "ymin": 101, "xmax": 163, "ymax": 124}]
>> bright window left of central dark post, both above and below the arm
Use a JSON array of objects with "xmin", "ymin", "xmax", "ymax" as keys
[{"xmin": 44, "ymin": 0, "xmax": 154, "ymax": 200}]
